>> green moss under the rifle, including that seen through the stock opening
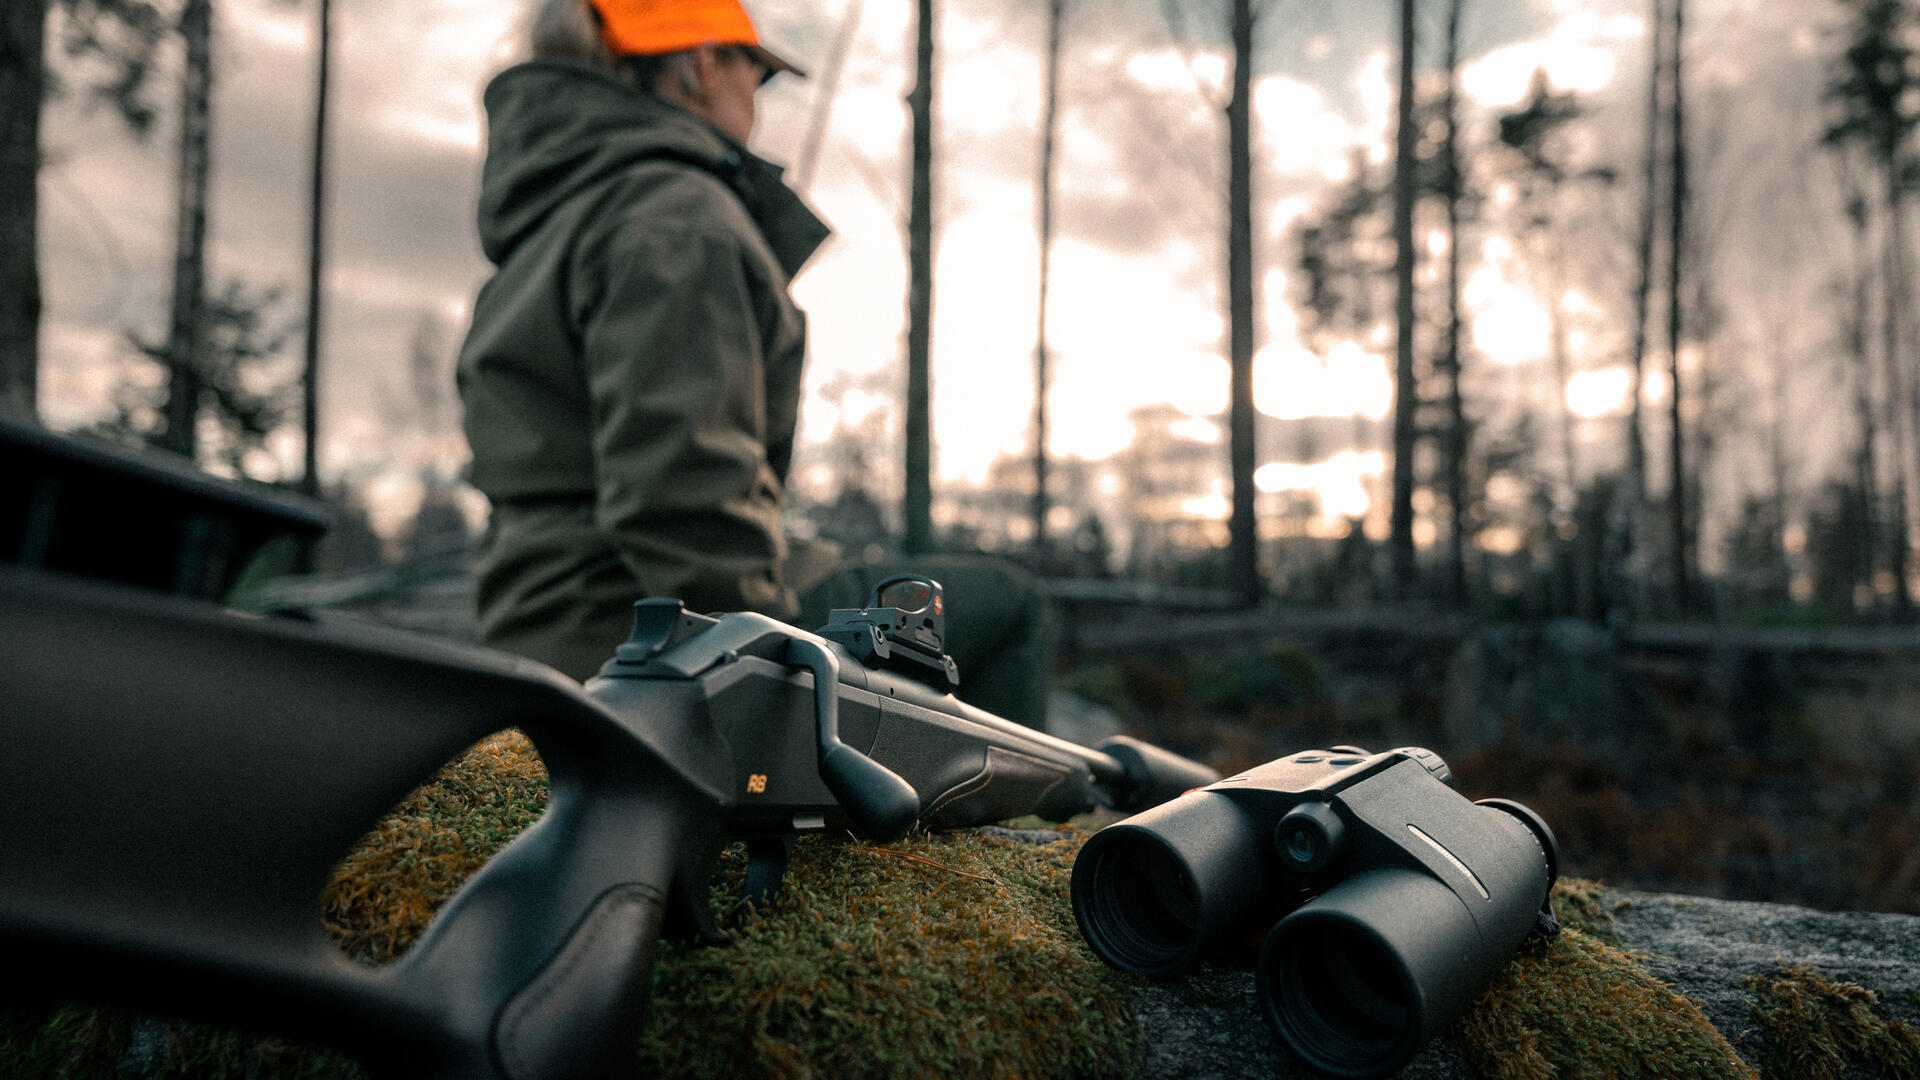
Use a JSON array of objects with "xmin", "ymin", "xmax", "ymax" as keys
[{"xmin": 0, "ymin": 732, "xmax": 1139, "ymax": 1080}]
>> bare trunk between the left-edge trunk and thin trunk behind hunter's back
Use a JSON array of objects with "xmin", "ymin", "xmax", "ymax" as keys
[{"xmin": 159, "ymin": 0, "xmax": 213, "ymax": 459}]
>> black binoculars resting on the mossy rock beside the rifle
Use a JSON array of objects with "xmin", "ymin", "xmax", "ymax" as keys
[{"xmin": 1071, "ymin": 746, "xmax": 1559, "ymax": 1076}]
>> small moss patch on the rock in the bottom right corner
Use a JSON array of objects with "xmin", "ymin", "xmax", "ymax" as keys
[{"xmin": 1745, "ymin": 965, "xmax": 1920, "ymax": 1080}]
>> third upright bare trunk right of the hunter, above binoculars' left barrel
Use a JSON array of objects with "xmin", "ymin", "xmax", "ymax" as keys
[{"xmin": 1227, "ymin": 0, "xmax": 1261, "ymax": 605}]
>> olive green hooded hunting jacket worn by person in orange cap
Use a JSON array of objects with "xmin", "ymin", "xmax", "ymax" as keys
[{"xmin": 459, "ymin": 61, "xmax": 828, "ymax": 678}]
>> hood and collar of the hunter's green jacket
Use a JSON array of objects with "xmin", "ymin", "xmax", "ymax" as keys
[{"xmin": 480, "ymin": 60, "xmax": 828, "ymax": 277}]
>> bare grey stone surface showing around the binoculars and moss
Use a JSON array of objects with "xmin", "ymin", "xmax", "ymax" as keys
[{"xmin": 1135, "ymin": 892, "xmax": 1920, "ymax": 1080}]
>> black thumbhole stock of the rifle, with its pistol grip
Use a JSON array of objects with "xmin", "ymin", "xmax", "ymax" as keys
[{"xmin": 0, "ymin": 573, "xmax": 714, "ymax": 1078}]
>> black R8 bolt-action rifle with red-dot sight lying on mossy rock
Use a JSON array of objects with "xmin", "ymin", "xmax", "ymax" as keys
[{"xmin": 0, "ymin": 569, "xmax": 1217, "ymax": 1080}]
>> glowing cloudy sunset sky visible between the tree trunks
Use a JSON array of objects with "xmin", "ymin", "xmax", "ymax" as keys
[{"xmin": 26, "ymin": 0, "xmax": 1889, "ymax": 611}]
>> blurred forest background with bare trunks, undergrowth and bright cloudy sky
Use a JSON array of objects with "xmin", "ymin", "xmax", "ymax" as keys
[{"xmin": 0, "ymin": 0, "xmax": 1920, "ymax": 911}]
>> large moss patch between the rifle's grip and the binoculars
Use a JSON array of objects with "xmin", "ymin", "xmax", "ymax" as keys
[{"xmin": 639, "ymin": 834, "xmax": 1139, "ymax": 1078}]
